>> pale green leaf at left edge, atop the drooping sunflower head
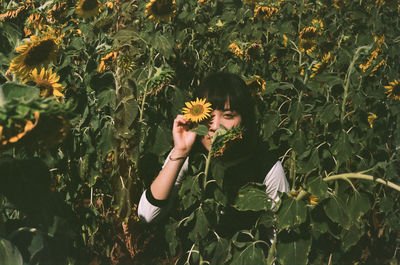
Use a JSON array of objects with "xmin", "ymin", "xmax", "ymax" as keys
[{"xmin": 0, "ymin": 82, "xmax": 40, "ymax": 106}]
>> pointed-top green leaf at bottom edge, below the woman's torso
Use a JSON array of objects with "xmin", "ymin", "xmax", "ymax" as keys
[{"xmin": 230, "ymin": 242, "xmax": 267, "ymax": 265}]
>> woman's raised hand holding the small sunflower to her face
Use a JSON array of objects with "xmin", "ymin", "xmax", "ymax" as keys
[{"xmin": 171, "ymin": 115, "xmax": 197, "ymax": 157}]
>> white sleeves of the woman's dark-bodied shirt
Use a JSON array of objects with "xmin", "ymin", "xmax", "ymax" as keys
[{"xmin": 138, "ymin": 150, "xmax": 289, "ymax": 223}]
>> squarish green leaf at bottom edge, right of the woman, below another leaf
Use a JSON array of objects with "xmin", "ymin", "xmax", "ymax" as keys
[{"xmin": 276, "ymin": 231, "xmax": 311, "ymax": 265}]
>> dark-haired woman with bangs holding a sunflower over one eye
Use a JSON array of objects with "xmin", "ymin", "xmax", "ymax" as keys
[{"xmin": 138, "ymin": 73, "xmax": 289, "ymax": 224}]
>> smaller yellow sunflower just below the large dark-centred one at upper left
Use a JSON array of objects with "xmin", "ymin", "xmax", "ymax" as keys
[{"xmin": 25, "ymin": 68, "xmax": 64, "ymax": 97}]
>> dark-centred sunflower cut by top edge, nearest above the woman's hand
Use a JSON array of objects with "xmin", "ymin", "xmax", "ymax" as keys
[{"xmin": 145, "ymin": 0, "xmax": 176, "ymax": 22}]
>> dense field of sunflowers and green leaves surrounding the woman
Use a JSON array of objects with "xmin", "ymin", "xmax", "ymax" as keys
[{"xmin": 0, "ymin": 0, "xmax": 400, "ymax": 265}]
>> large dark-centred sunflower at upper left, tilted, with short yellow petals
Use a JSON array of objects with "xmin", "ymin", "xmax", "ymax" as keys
[{"xmin": 10, "ymin": 34, "xmax": 60, "ymax": 79}]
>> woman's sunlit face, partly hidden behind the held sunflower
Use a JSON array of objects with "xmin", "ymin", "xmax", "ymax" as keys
[{"xmin": 201, "ymin": 101, "xmax": 242, "ymax": 151}]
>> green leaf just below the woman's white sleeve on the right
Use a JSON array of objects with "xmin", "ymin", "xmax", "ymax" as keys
[{"xmin": 277, "ymin": 194, "xmax": 307, "ymax": 230}]
